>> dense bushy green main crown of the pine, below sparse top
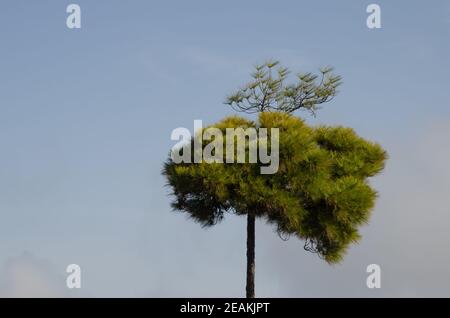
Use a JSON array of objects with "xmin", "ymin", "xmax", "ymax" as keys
[{"xmin": 163, "ymin": 112, "xmax": 386, "ymax": 263}]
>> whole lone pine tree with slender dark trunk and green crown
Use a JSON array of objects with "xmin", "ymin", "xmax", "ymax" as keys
[{"xmin": 163, "ymin": 62, "xmax": 387, "ymax": 298}]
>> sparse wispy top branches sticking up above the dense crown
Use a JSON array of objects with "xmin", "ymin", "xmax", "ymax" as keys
[{"xmin": 225, "ymin": 61, "xmax": 342, "ymax": 114}]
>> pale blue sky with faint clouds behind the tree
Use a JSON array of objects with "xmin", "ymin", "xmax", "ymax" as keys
[{"xmin": 0, "ymin": 0, "xmax": 450, "ymax": 297}]
